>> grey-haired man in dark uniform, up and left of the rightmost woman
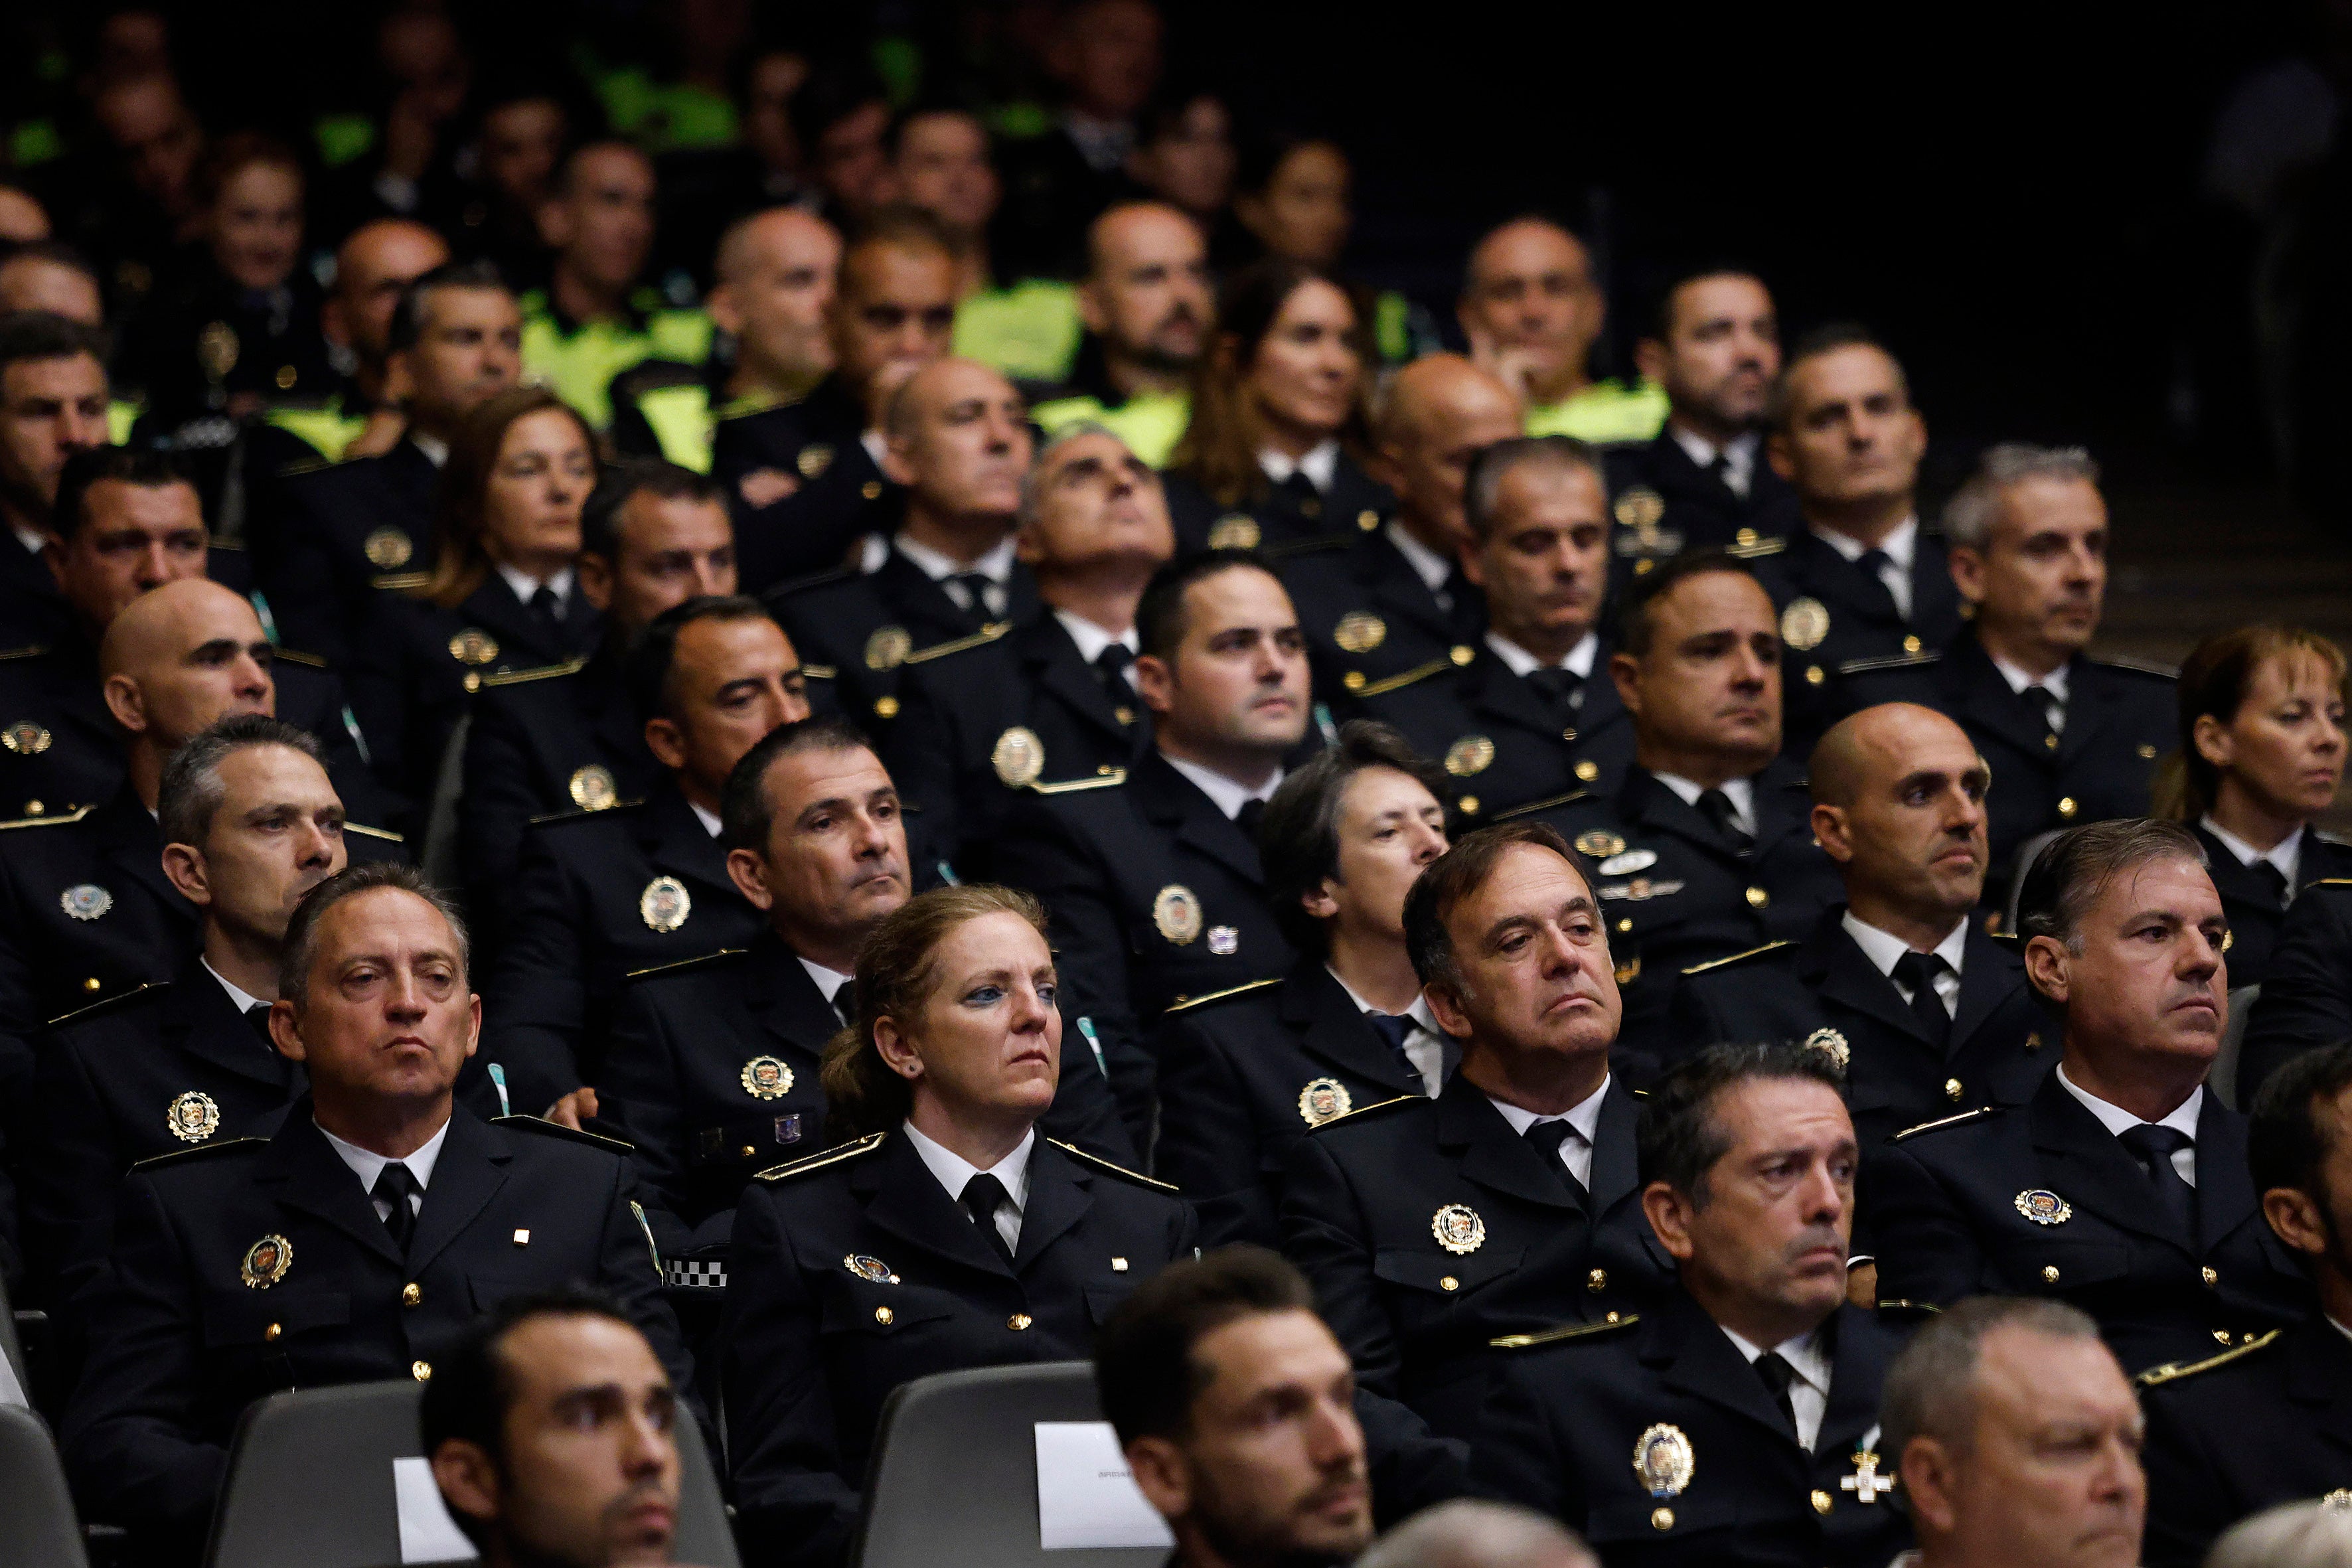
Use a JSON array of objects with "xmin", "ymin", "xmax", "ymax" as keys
[{"xmin": 1832, "ymin": 444, "xmax": 2180, "ymax": 905}]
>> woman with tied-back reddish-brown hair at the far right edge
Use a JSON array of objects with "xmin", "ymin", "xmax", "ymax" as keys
[{"xmin": 2157, "ymin": 625, "xmax": 2352, "ymax": 987}]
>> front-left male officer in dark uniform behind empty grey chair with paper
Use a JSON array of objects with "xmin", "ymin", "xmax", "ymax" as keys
[{"xmin": 61, "ymin": 865, "xmax": 687, "ymax": 1561}]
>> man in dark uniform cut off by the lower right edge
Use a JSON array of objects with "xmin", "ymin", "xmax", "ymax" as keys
[{"xmin": 2138, "ymin": 1046, "xmax": 2352, "ymax": 1568}]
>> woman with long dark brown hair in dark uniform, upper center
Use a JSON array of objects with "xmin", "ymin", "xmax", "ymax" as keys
[{"xmin": 1166, "ymin": 256, "xmax": 1395, "ymax": 550}]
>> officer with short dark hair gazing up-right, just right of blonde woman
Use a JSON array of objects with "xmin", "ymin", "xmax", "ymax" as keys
[{"xmin": 1152, "ymin": 720, "xmax": 1460, "ymax": 1246}]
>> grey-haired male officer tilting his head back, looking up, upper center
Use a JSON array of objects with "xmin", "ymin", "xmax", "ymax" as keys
[{"xmin": 889, "ymin": 423, "xmax": 1176, "ymax": 879}]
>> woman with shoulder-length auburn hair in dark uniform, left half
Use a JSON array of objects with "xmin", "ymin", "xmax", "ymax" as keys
[{"xmin": 351, "ymin": 388, "xmax": 602, "ymax": 799}]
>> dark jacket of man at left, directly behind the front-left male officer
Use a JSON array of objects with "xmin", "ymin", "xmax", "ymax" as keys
[{"xmin": 19, "ymin": 957, "xmax": 308, "ymax": 1312}]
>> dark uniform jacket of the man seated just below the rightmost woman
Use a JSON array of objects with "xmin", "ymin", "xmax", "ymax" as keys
[{"xmin": 1861, "ymin": 1072, "xmax": 2312, "ymax": 1373}]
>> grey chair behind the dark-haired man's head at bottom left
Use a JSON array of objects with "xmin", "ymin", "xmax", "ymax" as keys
[{"xmin": 204, "ymin": 1380, "xmax": 741, "ymax": 1568}]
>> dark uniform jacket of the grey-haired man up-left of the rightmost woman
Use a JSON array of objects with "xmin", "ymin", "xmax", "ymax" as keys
[{"xmin": 1835, "ymin": 630, "xmax": 2180, "ymax": 903}]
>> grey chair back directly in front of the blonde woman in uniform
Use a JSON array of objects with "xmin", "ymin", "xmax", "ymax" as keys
[{"xmin": 852, "ymin": 1361, "xmax": 1166, "ymax": 1568}]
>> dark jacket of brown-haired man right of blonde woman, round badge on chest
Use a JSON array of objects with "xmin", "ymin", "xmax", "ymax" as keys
[{"xmin": 1282, "ymin": 1074, "xmax": 1672, "ymax": 1441}]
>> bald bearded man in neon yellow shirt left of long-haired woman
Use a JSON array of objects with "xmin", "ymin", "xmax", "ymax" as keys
[{"xmin": 1032, "ymin": 202, "xmax": 1216, "ymax": 468}]
